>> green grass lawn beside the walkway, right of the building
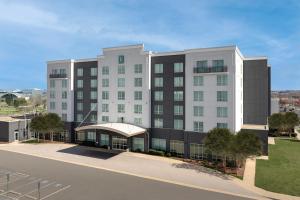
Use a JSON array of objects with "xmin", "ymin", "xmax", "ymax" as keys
[{"xmin": 255, "ymin": 139, "xmax": 300, "ymax": 196}]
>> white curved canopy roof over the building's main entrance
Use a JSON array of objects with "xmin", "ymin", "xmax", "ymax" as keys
[{"xmin": 75, "ymin": 123, "xmax": 146, "ymax": 137}]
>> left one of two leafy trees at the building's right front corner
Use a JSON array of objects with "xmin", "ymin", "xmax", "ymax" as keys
[{"xmin": 204, "ymin": 128, "xmax": 233, "ymax": 169}]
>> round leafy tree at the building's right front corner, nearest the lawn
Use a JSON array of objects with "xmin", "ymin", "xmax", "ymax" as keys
[{"xmin": 231, "ymin": 130, "xmax": 262, "ymax": 167}]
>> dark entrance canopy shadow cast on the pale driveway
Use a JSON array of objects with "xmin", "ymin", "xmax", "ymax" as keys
[{"xmin": 58, "ymin": 145, "xmax": 122, "ymax": 160}]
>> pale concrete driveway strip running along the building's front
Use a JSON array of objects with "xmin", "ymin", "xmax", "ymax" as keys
[{"xmin": 0, "ymin": 144, "xmax": 260, "ymax": 198}]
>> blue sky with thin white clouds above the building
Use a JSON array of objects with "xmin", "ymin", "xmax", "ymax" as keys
[{"xmin": 0, "ymin": 0, "xmax": 300, "ymax": 90}]
